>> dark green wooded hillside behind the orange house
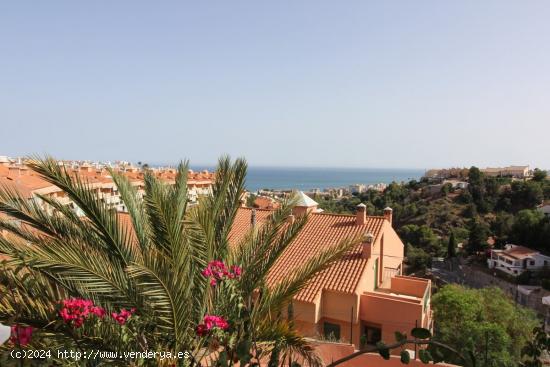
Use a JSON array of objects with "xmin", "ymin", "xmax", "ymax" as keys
[{"xmin": 316, "ymin": 167, "xmax": 550, "ymax": 270}]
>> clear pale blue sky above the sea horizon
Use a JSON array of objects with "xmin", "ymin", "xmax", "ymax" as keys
[{"xmin": 0, "ymin": 0, "xmax": 550, "ymax": 168}]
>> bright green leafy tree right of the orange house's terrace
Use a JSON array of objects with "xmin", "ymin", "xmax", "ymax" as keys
[{"xmin": 432, "ymin": 285, "xmax": 538, "ymax": 367}]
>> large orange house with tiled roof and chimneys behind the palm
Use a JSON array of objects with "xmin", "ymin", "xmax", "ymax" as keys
[{"xmin": 230, "ymin": 193, "xmax": 432, "ymax": 348}]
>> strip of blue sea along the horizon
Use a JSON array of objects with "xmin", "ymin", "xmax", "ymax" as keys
[{"xmin": 188, "ymin": 166, "xmax": 425, "ymax": 192}]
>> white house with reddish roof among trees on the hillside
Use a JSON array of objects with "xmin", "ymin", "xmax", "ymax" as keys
[{"xmin": 487, "ymin": 245, "xmax": 550, "ymax": 276}]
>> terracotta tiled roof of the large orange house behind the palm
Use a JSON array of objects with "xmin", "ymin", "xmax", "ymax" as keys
[{"xmin": 226, "ymin": 208, "xmax": 385, "ymax": 302}]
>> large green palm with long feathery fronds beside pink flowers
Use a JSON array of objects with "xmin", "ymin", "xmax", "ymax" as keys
[{"xmin": 0, "ymin": 157, "xmax": 356, "ymax": 365}]
